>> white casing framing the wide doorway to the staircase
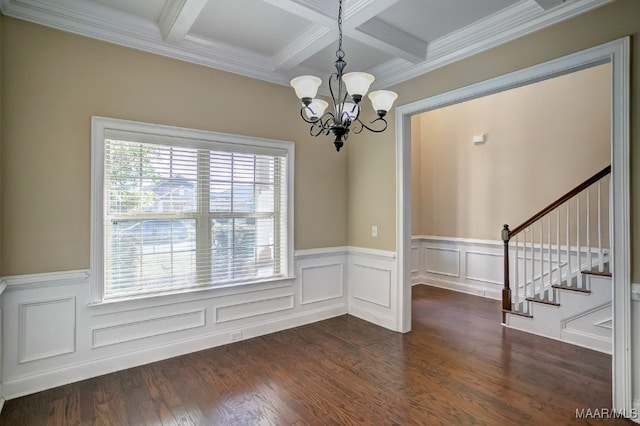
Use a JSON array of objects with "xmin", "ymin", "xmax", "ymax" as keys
[{"xmin": 396, "ymin": 38, "xmax": 631, "ymax": 410}]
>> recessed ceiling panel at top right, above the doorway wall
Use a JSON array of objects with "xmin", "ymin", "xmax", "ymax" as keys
[{"xmin": 378, "ymin": 0, "xmax": 519, "ymax": 41}]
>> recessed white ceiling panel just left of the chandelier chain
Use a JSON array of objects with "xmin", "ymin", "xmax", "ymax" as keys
[{"xmin": 191, "ymin": 0, "xmax": 311, "ymax": 55}]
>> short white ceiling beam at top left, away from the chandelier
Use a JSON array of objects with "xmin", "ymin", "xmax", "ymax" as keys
[{"xmin": 158, "ymin": 0, "xmax": 207, "ymax": 43}]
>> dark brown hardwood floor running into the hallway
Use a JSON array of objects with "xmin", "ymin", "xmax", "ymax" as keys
[{"xmin": 0, "ymin": 286, "xmax": 631, "ymax": 425}]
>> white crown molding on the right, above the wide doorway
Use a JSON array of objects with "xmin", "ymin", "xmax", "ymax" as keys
[{"xmin": 370, "ymin": 0, "xmax": 615, "ymax": 87}]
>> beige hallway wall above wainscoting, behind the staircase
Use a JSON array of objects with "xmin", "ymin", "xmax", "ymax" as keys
[{"xmin": 411, "ymin": 64, "xmax": 611, "ymax": 241}]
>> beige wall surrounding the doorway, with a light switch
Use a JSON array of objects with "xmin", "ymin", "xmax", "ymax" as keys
[{"xmin": 348, "ymin": 0, "xmax": 640, "ymax": 281}]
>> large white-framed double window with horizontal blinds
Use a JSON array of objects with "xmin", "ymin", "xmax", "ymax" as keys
[{"xmin": 92, "ymin": 117, "xmax": 293, "ymax": 302}]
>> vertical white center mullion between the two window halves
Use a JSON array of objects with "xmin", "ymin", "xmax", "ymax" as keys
[{"xmin": 196, "ymin": 149, "xmax": 211, "ymax": 284}]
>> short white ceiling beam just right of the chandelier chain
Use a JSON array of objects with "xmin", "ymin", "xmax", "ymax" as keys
[{"xmin": 346, "ymin": 18, "xmax": 428, "ymax": 64}]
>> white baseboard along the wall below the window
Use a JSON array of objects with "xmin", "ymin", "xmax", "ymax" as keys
[{"xmin": 3, "ymin": 303, "xmax": 347, "ymax": 399}]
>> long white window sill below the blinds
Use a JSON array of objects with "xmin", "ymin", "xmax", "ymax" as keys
[{"xmin": 87, "ymin": 276, "xmax": 296, "ymax": 316}]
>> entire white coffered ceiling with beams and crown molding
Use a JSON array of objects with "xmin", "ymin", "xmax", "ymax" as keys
[{"xmin": 0, "ymin": 0, "xmax": 613, "ymax": 88}]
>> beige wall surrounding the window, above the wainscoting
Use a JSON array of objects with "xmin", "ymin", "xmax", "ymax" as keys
[{"xmin": 1, "ymin": 17, "xmax": 347, "ymax": 275}]
